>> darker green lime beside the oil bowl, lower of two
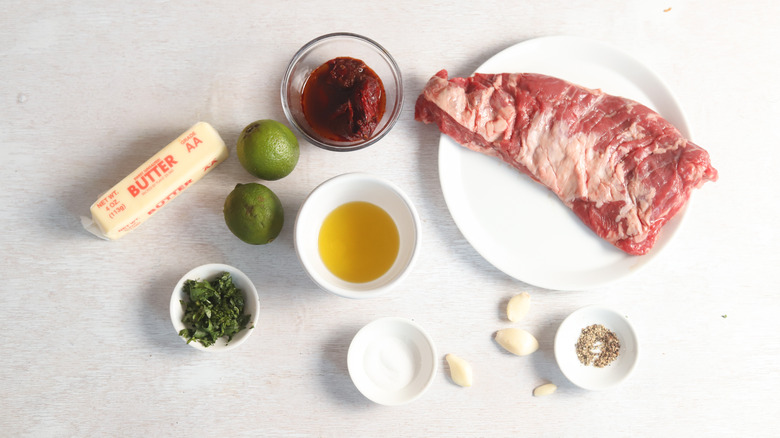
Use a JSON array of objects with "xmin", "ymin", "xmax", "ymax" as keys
[{"xmin": 222, "ymin": 183, "xmax": 284, "ymax": 245}]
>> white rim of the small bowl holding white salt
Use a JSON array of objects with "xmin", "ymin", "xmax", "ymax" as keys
[{"xmin": 347, "ymin": 316, "xmax": 438, "ymax": 406}]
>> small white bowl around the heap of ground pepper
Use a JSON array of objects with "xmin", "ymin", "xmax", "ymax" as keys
[{"xmin": 554, "ymin": 306, "xmax": 639, "ymax": 390}]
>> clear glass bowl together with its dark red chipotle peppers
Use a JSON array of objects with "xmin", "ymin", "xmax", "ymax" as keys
[{"xmin": 281, "ymin": 33, "xmax": 403, "ymax": 152}]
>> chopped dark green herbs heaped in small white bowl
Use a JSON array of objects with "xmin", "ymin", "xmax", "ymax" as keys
[{"xmin": 179, "ymin": 272, "xmax": 252, "ymax": 347}]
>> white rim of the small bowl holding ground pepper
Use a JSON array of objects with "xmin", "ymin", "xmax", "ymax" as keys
[{"xmin": 553, "ymin": 305, "xmax": 639, "ymax": 391}]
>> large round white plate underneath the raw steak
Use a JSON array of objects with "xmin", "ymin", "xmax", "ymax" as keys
[{"xmin": 439, "ymin": 36, "xmax": 690, "ymax": 290}]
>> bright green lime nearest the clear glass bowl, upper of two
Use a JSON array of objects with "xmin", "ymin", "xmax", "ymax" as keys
[{"xmin": 236, "ymin": 120, "xmax": 300, "ymax": 181}]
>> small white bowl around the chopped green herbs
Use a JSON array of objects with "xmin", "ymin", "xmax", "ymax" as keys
[{"xmin": 170, "ymin": 263, "xmax": 260, "ymax": 352}]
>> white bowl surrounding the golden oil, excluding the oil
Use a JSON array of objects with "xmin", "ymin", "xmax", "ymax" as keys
[{"xmin": 294, "ymin": 173, "xmax": 422, "ymax": 299}]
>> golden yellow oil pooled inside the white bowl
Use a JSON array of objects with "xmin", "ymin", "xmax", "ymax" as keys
[{"xmin": 318, "ymin": 201, "xmax": 400, "ymax": 283}]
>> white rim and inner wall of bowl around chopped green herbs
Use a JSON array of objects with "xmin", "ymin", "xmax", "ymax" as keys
[{"xmin": 169, "ymin": 263, "xmax": 260, "ymax": 353}]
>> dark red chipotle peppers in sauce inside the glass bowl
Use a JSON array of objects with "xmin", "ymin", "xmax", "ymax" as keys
[{"xmin": 301, "ymin": 57, "xmax": 385, "ymax": 141}]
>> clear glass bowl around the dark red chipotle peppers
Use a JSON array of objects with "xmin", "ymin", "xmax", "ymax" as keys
[{"xmin": 282, "ymin": 32, "xmax": 404, "ymax": 152}]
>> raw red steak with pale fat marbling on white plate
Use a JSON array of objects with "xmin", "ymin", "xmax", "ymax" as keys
[{"xmin": 415, "ymin": 70, "xmax": 718, "ymax": 255}]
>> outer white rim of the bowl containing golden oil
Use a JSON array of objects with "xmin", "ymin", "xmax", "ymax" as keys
[{"xmin": 293, "ymin": 172, "xmax": 422, "ymax": 299}]
